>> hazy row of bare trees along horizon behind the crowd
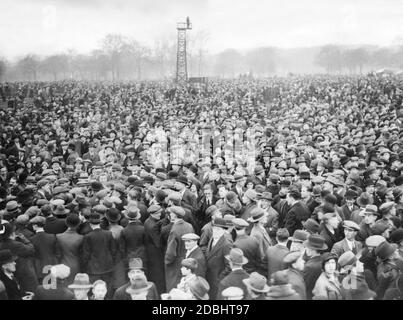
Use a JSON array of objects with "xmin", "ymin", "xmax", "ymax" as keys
[{"xmin": 0, "ymin": 31, "xmax": 403, "ymax": 81}]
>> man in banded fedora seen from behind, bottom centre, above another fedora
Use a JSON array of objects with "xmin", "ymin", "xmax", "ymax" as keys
[{"xmin": 217, "ymin": 248, "xmax": 249, "ymax": 300}]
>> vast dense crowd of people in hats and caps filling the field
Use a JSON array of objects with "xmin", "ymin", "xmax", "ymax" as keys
[{"xmin": 0, "ymin": 75, "xmax": 403, "ymax": 300}]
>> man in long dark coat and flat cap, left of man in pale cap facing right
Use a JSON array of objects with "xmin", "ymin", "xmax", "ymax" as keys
[{"xmin": 144, "ymin": 205, "xmax": 166, "ymax": 294}]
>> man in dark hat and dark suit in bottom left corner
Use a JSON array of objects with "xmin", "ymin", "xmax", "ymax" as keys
[{"xmin": 0, "ymin": 249, "xmax": 23, "ymax": 300}]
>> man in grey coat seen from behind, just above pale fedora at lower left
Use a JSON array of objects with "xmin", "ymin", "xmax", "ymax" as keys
[{"xmin": 56, "ymin": 213, "xmax": 84, "ymax": 284}]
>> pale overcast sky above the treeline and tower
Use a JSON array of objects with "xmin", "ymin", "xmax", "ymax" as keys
[{"xmin": 0, "ymin": 0, "xmax": 403, "ymax": 57}]
